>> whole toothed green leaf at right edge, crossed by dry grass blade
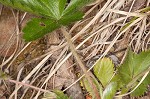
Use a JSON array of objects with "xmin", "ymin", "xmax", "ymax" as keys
[{"xmin": 116, "ymin": 50, "xmax": 150, "ymax": 96}]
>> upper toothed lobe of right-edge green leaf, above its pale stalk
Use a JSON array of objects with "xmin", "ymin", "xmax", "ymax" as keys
[{"xmin": 118, "ymin": 51, "xmax": 150, "ymax": 84}]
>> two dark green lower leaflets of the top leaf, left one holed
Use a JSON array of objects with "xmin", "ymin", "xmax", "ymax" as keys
[{"xmin": 23, "ymin": 13, "xmax": 83, "ymax": 41}]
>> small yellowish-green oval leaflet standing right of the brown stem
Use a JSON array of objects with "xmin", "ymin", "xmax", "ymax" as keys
[{"xmin": 93, "ymin": 58, "xmax": 114, "ymax": 87}]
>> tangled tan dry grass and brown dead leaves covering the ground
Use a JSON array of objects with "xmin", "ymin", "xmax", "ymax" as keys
[{"xmin": 0, "ymin": 0, "xmax": 150, "ymax": 99}]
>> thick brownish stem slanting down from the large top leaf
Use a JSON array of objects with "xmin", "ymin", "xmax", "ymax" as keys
[{"xmin": 61, "ymin": 27, "xmax": 100, "ymax": 99}]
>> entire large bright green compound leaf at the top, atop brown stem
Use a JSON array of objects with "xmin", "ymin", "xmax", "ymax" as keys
[{"xmin": 0, "ymin": 0, "xmax": 94, "ymax": 41}]
